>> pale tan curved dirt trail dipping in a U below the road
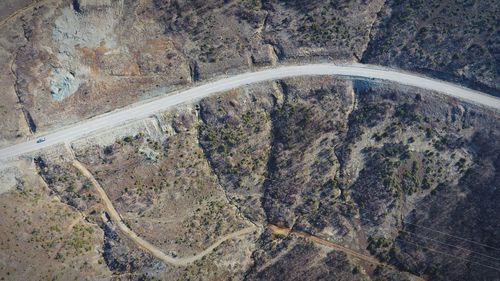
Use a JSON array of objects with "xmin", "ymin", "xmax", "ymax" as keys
[{"xmin": 73, "ymin": 159, "xmax": 256, "ymax": 266}]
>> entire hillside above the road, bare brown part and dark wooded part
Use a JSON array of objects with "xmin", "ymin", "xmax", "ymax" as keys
[{"xmin": 0, "ymin": 0, "xmax": 499, "ymax": 147}]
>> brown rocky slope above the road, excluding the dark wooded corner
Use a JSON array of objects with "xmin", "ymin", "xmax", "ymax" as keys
[{"xmin": 0, "ymin": 0, "xmax": 381, "ymax": 144}]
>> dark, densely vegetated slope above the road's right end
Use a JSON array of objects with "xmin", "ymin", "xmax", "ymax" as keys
[{"xmin": 361, "ymin": 0, "xmax": 500, "ymax": 96}]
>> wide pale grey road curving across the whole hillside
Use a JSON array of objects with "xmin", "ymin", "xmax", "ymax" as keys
[{"xmin": 0, "ymin": 63, "xmax": 500, "ymax": 161}]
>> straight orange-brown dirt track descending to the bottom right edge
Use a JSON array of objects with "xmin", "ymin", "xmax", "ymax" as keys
[{"xmin": 268, "ymin": 224, "xmax": 425, "ymax": 281}]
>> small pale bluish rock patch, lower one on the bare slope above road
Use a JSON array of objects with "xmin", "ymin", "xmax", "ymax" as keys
[{"xmin": 50, "ymin": 68, "xmax": 79, "ymax": 101}]
